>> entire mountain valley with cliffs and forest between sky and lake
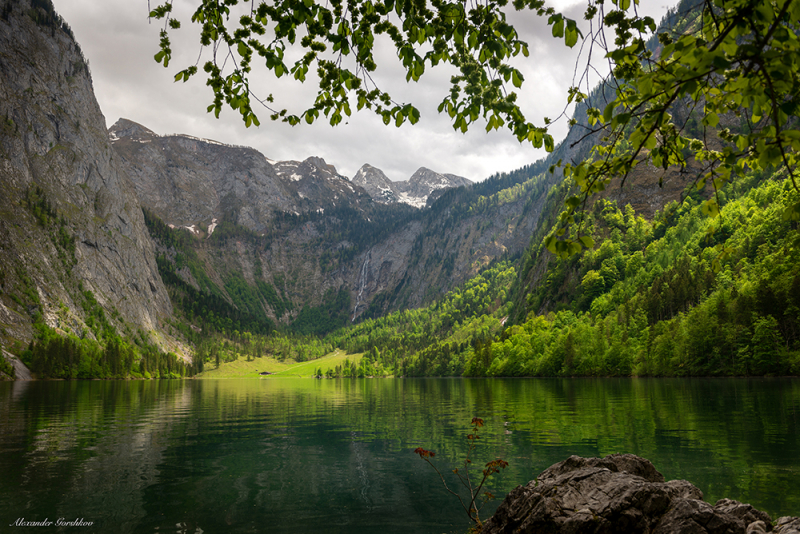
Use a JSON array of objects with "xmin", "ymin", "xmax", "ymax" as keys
[{"xmin": 0, "ymin": 0, "xmax": 800, "ymax": 386}]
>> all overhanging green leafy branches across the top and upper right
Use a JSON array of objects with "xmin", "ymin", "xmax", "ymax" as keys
[{"xmin": 151, "ymin": 0, "xmax": 800, "ymax": 255}]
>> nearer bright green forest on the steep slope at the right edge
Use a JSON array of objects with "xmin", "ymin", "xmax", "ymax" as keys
[{"xmin": 482, "ymin": 173, "xmax": 800, "ymax": 376}]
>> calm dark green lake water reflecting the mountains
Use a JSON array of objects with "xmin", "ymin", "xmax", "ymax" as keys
[{"xmin": 0, "ymin": 378, "xmax": 800, "ymax": 534}]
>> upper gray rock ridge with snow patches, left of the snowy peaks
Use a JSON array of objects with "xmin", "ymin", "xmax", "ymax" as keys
[{"xmin": 108, "ymin": 119, "xmax": 370, "ymax": 233}]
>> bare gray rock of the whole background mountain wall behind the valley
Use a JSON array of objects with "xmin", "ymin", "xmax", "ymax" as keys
[{"xmin": 108, "ymin": 119, "xmax": 504, "ymax": 321}]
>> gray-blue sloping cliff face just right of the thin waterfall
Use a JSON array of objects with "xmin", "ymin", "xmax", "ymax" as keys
[{"xmin": 355, "ymin": 175, "xmax": 552, "ymax": 317}]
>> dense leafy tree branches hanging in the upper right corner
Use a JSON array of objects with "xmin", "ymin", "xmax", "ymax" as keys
[{"xmin": 547, "ymin": 0, "xmax": 800, "ymax": 260}]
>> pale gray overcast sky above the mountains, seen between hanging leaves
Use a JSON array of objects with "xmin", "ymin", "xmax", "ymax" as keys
[{"xmin": 53, "ymin": 0, "xmax": 673, "ymax": 181}]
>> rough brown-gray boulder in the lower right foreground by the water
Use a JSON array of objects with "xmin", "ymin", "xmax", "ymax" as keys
[{"xmin": 482, "ymin": 454, "xmax": 800, "ymax": 534}]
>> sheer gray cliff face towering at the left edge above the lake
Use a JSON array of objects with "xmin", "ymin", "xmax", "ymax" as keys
[{"xmin": 0, "ymin": 0, "xmax": 172, "ymax": 352}]
